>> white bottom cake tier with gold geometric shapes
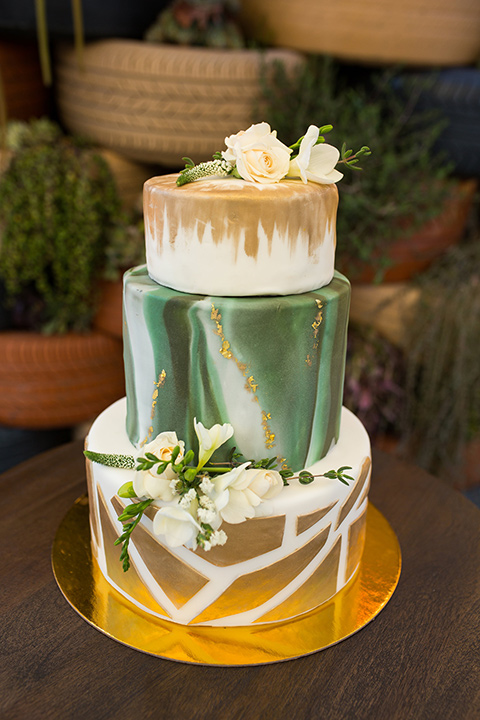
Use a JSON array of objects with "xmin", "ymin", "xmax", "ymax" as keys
[{"xmin": 86, "ymin": 399, "xmax": 371, "ymax": 626}]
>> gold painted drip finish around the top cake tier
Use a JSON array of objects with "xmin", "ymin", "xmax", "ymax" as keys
[{"xmin": 144, "ymin": 175, "xmax": 338, "ymax": 259}]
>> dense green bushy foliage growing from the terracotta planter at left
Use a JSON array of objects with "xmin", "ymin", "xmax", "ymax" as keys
[{"xmin": 0, "ymin": 119, "xmax": 141, "ymax": 333}]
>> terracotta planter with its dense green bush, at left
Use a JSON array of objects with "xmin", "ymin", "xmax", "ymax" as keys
[{"xmin": 0, "ymin": 120, "xmax": 133, "ymax": 428}]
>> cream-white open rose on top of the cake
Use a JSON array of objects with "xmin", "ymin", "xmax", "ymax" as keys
[{"xmin": 222, "ymin": 123, "xmax": 292, "ymax": 184}]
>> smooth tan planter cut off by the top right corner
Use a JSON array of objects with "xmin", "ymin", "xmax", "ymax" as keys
[{"xmin": 242, "ymin": 0, "xmax": 480, "ymax": 65}]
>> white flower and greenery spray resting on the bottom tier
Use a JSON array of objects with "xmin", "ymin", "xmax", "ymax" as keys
[{"xmin": 85, "ymin": 419, "xmax": 353, "ymax": 571}]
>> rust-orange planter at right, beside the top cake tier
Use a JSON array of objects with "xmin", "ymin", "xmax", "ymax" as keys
[{"xmin": 337, "ymin": 180, "xmax": 477, "ymax": 283}]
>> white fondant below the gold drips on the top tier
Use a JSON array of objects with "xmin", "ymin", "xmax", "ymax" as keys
[{"xmin": 144, "ymin": 178, "xmax": 335, "ymax": 297}]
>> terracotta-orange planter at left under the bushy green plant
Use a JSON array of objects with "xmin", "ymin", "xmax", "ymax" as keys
[{"xmin": 0, "ymin": 331, "xmax": 125, "ymax": 429}]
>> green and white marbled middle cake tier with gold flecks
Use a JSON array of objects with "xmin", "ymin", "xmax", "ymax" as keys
[{"xmin": 124, "ymin": 267, "xmax": 350, "ymax": 470}]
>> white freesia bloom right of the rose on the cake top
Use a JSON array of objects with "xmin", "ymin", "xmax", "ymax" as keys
[{"xmin": 288, "ymin": 125, "xmax": 343, "ymax": 185}]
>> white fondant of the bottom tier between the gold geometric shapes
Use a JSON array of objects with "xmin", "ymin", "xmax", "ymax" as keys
[{"xmin": 87, "ymin": 399, "xmax": 370, "ymax": 626}]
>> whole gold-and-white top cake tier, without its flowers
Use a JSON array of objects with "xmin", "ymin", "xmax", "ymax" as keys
[{"xmin": 144, "ymin": 175, "xmax": 338, "ymax": 297}]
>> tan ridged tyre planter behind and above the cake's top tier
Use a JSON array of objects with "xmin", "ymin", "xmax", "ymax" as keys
[{"xmin": 56, "ymin": 40, "xmax": 301, "ymax": 168}]
